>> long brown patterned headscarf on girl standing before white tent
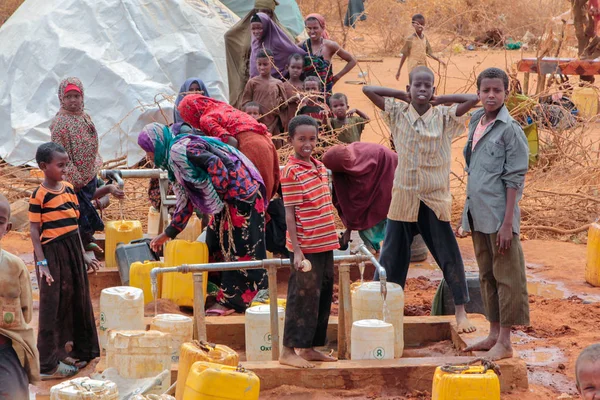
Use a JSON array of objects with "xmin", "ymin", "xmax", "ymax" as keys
[{"xmin": 50, "ymin": 77, "xmax": 102, "ymax": 190}]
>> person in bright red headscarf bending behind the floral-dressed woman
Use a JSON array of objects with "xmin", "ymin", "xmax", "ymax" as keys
[{"xmin": 179, "ymin": 94, "xmax": 279, "ymax": 201}]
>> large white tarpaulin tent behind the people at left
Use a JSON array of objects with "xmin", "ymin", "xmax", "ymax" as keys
[{"xmin": 0, "ymin": 0, "xmax": 239, "ymax": 164}]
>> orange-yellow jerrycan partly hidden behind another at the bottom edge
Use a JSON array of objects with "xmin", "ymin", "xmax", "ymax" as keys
[{"xmin": 175, "ymin": 341, "xmax": 240, "ymax": 400}]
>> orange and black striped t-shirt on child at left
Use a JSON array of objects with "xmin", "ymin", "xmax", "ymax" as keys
[{"xmin": 29, "ymin": 182, "xmax": 79, "ymax": 244}]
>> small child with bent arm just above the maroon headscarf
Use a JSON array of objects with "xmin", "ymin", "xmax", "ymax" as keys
[{"xmin": 329, "ymin": 93, "xmax": 370, "ymax": 144}]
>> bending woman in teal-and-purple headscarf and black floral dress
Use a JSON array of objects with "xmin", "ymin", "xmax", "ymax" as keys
[{"xmin": 138, "ymin": 123, "xmax": 268, "ymax": 315}]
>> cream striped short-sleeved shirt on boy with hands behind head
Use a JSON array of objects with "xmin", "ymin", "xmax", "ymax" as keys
[{"xmin": 385, "ymin": 98, "xmax": 468, "ymax": 222}]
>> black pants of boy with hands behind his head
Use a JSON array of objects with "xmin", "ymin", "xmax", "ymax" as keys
[{"xmin": 379, "ymin": 202, "xmax": 469, "ymax": 305}]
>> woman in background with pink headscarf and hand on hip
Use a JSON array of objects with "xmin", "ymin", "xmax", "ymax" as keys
[{"xmin": 300, "ymin": 14, "xmax": 356, "ymax": 95}]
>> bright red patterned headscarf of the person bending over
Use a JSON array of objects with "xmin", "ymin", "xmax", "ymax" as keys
[{"xmin": 178, "ymin": 94, "xmax": 269, "ymax": 138}]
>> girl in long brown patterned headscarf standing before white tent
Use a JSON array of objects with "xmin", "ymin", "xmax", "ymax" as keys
[{"xmin": 50, "ymin": 77, "xmax": 125, "ymax": 250}]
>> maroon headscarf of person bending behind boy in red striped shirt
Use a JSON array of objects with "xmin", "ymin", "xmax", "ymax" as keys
[{"xmin": 322, "ymin": 142, "xmax": 398, "ymax": 230}]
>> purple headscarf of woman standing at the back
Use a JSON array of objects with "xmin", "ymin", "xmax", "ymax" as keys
[{"xmin": 250, "ymin": 12, "xmax": 306, "ymax": 78}]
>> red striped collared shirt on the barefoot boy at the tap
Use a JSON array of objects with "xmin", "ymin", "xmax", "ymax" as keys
[{"xmin": 281, "ymin": 156, "xmax": 339, "ymax": 253}]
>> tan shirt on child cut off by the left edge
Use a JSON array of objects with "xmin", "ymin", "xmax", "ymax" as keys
[{"xmin": 0, "ymin": 249, "xmax": 40, "ymax": 383}]
